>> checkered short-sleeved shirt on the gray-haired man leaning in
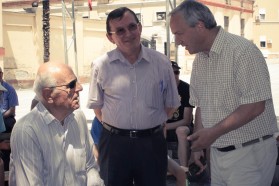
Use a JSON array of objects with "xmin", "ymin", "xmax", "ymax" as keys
[{"xmin": 190, "ymin": 28, "xmax": 278, "ymax": 147}]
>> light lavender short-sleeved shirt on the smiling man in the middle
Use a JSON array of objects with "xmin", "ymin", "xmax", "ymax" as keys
[{"xmin": 87, "ymin": 46, "xmax": 180, "ymax": 129}]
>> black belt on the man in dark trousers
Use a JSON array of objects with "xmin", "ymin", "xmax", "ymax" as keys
[{"xmin": 103, "ymin": 122, "xmax": 163, "ymax": 138}]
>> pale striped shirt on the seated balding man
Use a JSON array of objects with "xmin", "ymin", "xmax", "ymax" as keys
[{"xmin": 10, "ymin": 102, "xmax": 104, "ymax": 186}]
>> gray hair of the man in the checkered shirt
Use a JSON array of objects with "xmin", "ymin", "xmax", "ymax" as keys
[{"xmin": 169, "ymin": 0, "xmax": 217, "ymax": 29}]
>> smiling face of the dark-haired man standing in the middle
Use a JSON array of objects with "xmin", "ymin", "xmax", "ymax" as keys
[{"xmin": 107, "ymin": 12, "xmax": 142, "ymax": 53}]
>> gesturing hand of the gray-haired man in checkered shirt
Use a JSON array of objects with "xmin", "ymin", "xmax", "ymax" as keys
[{"xmin": 187, "ymin": 128, "xmax": 217, "ymax": 151}]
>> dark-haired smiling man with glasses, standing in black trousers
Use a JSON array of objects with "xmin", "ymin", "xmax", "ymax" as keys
[{"xmin": 88, "ymin": 7, "xmax": 180, "ymax": 186}]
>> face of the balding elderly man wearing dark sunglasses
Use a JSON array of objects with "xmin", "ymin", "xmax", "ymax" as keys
[{"xmin": 51, "ymin": 69, "xmax": 83, "ymax": 113}]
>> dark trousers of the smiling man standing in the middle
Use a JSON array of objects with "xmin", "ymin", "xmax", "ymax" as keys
[{"xmin": 99, "ymin": 129, "xmax": 167, "ymax": 186}]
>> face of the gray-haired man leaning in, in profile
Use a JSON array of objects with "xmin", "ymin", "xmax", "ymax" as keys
[{"xmin": 170, "ymin": 13, "xmax": 202, "ymax": 54}]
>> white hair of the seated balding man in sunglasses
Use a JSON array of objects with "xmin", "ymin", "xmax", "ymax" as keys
[{"xmin": 33, "ymin": 72, "xmax": 57, "ymax": 101}]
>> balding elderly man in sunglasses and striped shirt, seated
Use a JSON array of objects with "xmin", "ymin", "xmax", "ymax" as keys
[{"xmin": 9, "ymin": 62, "xmax": 103, "ymax": 186}]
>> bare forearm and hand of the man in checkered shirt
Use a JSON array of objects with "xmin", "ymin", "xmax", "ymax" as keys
[{"xmin": 188, "ymin": 101, "xmax": 265, "ymax": 151}]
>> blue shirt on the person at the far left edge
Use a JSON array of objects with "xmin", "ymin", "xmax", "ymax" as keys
[{"xmin": 1, "ymin": 81, "xmax": 18, "ymax": 113}]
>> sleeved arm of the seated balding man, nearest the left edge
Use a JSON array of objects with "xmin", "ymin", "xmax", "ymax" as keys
[{"xmin": 10, "ymin": 128, "xmax": 44, "ymax": 186}]
